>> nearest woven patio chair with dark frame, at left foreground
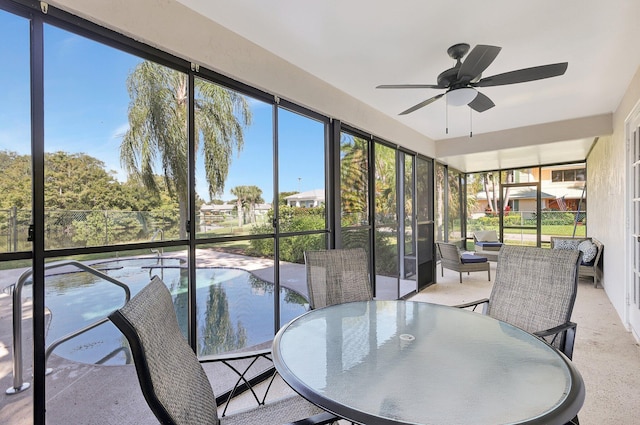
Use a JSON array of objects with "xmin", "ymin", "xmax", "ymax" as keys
[{"xmin": 109, "ymin": 277, "xmax": 337, "ymax": 425}]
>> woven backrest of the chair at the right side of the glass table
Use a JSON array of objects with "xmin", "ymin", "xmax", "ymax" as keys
[{"xmin": 487, "ymin": 245, "xmax": 580, "ymax": 347}]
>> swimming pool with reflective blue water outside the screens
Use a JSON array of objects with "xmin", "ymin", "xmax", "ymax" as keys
[{"xmin": 38, "ymin": 258, "xmax": 307, "ymax": 364}]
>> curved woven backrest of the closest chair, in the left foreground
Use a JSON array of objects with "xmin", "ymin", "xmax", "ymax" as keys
[{"xmin": 109, "ymin": 276, "xmax": 218, "ymax": 425}]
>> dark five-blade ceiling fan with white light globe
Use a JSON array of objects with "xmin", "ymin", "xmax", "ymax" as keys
[{"xmin": 376, "ymin": 43, "xmax": 568, "ymax": 115}]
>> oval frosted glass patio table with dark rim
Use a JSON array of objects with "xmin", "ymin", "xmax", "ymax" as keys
[{"xmin": 273, "ymin": 301, "xmax": 585, "ymax": 425}]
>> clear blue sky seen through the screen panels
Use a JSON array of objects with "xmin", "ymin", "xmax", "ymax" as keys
[{"xmin": 0, "ymin": 11, "xmax": 324, "ymax": 202}]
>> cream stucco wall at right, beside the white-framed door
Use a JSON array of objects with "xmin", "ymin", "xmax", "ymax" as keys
[{"xmin": 587, "ymin": 64, "xmax": 640, "ymax": 324}]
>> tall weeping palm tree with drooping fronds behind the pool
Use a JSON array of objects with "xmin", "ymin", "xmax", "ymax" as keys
[{"xmin": 120, "ymin": 61, "xmax": 251, "ymax": 238}]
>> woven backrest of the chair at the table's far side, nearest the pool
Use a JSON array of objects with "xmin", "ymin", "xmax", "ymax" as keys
[{"xmin": 304, "ymin": 248, "xmax": 373, "ymax": 308}]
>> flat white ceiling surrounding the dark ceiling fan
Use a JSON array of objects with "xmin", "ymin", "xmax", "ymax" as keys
[{"xmin": 178, "ymin": 0, "xmax": 640, "ymax": 171}]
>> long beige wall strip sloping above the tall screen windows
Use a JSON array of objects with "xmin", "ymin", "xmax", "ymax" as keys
[{"xmin": 50, "ymin": 0, "xmax": 435, "ymax": 157}]
